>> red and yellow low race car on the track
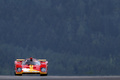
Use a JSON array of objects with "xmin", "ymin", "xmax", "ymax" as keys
[{"xmin": 14, "ymin": 57, "xmax": 48, "ymax": 76}]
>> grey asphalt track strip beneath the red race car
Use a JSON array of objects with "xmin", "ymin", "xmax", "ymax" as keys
[{"xmin": 0, "ymin": 76, "xmax": 120, "ymax": 80}]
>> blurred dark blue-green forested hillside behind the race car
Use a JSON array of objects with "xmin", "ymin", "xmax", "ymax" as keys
[{"xmin": 0, "ymin": 0, "xmax": 120, "ymax": 75}]
